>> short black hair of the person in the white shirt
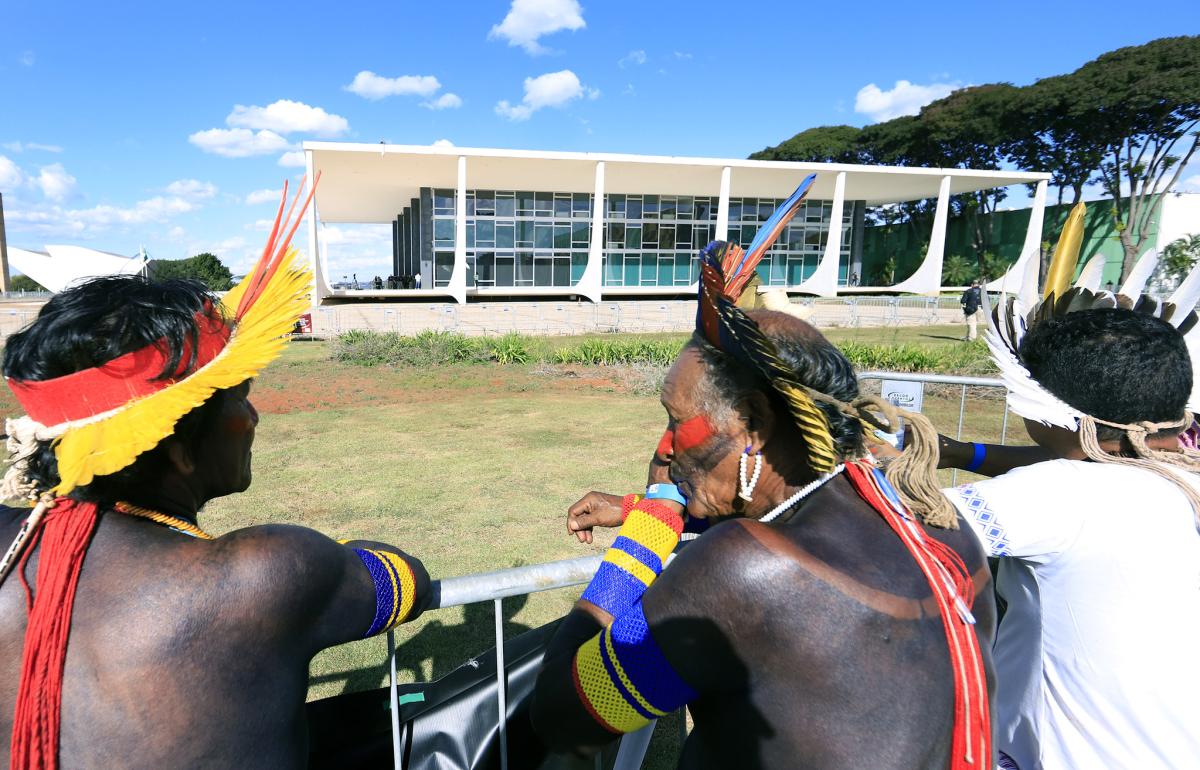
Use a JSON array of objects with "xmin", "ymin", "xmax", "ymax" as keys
[{"xmin": 1020, "ymin": 309, "xmax": 1193, "ymax": 440}]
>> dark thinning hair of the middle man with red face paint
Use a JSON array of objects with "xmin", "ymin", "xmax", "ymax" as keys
[{"xmin": 692, "ymin": 309, "xmax": 863, "ymax": 458}]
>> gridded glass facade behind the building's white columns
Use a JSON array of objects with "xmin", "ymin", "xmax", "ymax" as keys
[{"xmin": 394, "ymin": 188, "xmax": 854, "ymax": 291}]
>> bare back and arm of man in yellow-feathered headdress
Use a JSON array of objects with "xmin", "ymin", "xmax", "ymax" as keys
[{"xmin": 0, "ymin": 509, "xmax": 432, "ymax": 769}]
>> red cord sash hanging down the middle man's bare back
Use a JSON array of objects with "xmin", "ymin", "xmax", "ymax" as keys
[{"xmin": 846, "ymin": 463, "xmax": 991, "ymax": 770}]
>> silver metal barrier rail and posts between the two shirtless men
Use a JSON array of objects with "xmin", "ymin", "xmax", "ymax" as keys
[{"xmin": 388, "ymin": 557, "xmax": 654, "ymax": 770}]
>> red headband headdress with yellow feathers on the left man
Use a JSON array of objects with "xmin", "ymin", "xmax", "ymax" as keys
[{"xmin": 6, "ymin": 177, "xmax": 313, "ymax": 495}]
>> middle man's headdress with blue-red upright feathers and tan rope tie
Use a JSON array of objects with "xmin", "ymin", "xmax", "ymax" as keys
[{"xmin": 696, "ymin": 175, "xmax": 956, "ymax": 528}]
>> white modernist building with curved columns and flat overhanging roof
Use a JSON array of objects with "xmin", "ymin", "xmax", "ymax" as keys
[{"xmin": 304, "ymin": 142, "xmax": 1049, "ymax": 302}]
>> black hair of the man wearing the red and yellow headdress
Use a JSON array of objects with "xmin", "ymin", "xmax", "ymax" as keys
[{"xmin": 4, "ymin": 276, "xmax": 230, "ymax": 503}]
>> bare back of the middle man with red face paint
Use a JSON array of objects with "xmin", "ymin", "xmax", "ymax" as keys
[{"xmin": 535, "ymin": 479, "xmax": 995, "ymax": 770}]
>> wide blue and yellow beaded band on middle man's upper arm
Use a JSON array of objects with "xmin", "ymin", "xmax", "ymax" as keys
[{"xmin": 572, "ymin": 602, "xmax": 697, "ymax": 733}]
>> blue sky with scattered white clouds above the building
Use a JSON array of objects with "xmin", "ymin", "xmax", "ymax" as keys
[{"xmin": 0, "ymin": 0, "xmax": 1200, "ymax": 278}]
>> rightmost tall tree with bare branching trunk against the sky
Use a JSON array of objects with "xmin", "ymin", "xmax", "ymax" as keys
[{"xmin": 1070, "ymin": 36, "xmax": 1200, "ymax": 278}]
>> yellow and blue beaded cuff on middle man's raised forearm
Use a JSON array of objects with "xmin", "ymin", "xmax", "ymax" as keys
[{"xmin": 582, "ymin": 498, "xmax": 683, "ymax": 618}]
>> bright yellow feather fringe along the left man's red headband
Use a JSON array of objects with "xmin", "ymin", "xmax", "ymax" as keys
[{"xmin": 54, "ymin": 248, "xmax": 312, "ymax": 495}]
